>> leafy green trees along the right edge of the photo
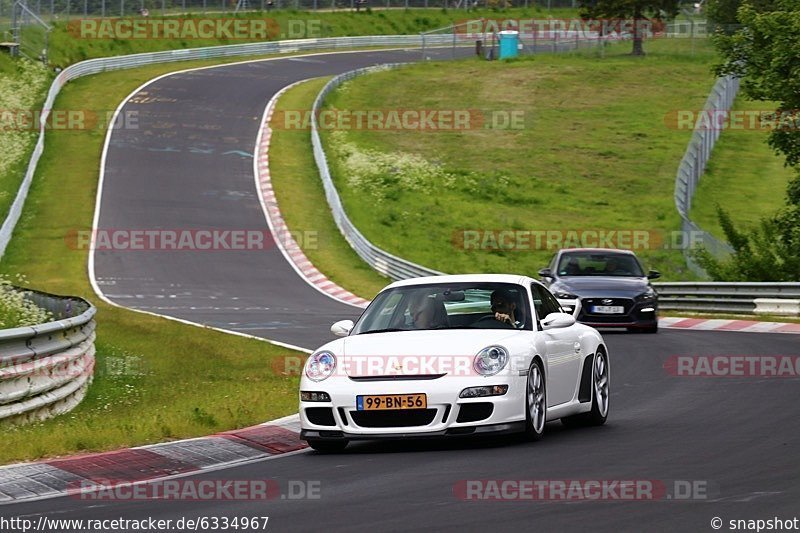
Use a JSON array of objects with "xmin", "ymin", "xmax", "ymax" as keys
[{"xmin": 696, "ymin": 0, "xmax": 800, "ymax": 281}]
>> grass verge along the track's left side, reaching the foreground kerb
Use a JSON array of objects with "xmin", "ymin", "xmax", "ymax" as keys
[{"xmin": 0, "ymin": 52, "xmax": 330, "ymax": 463}]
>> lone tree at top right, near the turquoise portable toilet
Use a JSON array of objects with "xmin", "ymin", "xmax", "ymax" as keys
[{"xmin": 580, "ymin": 0, "xmax": 680, "ymax": 56}]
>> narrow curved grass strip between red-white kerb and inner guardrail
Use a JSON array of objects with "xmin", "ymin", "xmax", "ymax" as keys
[{"xmin": 269, "ymin": 78, "xmax": 390, "ymax": 299}]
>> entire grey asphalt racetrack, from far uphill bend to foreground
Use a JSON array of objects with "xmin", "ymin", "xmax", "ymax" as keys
[{"xmin": 0, "ymin": 47, "xmax": 800, "ymax": 532}]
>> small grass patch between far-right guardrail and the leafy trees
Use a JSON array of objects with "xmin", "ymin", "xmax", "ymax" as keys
[{"xmin": 691, "ymin": 97, "xmax": 794, "ymax": 240}]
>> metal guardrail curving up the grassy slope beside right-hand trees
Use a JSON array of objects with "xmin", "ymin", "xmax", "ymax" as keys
[{"xmin": 675, "ymin": 76, "xmax": 739, "ymax": 275}]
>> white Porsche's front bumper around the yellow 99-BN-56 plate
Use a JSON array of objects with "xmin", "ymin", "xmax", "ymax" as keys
[{"xmin": 300, "ymin": 372, "xmax": 526, "ymax": 440}]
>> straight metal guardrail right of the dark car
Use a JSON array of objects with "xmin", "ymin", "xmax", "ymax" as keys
[{"xmin": 653, "ymin": 281, "xmax": 800, "ymax": 314}]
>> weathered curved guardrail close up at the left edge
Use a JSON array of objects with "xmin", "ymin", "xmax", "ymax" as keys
[{"xmin": 0, "ymin": 289, "xmax": 96, "ymax": 423}]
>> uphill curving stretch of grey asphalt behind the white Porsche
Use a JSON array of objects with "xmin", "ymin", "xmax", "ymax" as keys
[{"xmin": 94, "ymin": 49, "xmax": 466, "ymax": 349}]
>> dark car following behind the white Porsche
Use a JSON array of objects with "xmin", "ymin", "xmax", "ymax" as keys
[{"xmin": 539, "ymin": 248, "xmax": 661, "ymax": 333}]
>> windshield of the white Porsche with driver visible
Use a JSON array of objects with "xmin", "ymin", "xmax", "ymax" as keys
[{"xmin": 352, "ymin": 282, "xmax": 531, "ymax": 335}]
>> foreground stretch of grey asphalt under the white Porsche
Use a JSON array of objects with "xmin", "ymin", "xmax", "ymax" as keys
[{"xmin": 6, "ymin": 330, "xmax": 800, "ymax": 532}]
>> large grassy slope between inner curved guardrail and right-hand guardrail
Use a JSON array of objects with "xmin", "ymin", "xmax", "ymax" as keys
[{"xmin": 323, "ymin": 40, "xmax": 714, "ymax": 279}]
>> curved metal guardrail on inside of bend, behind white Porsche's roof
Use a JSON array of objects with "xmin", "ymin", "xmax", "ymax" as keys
[{"xmin": 311, "ymin": 64, "xmax": 442, "ymax": 280}]
